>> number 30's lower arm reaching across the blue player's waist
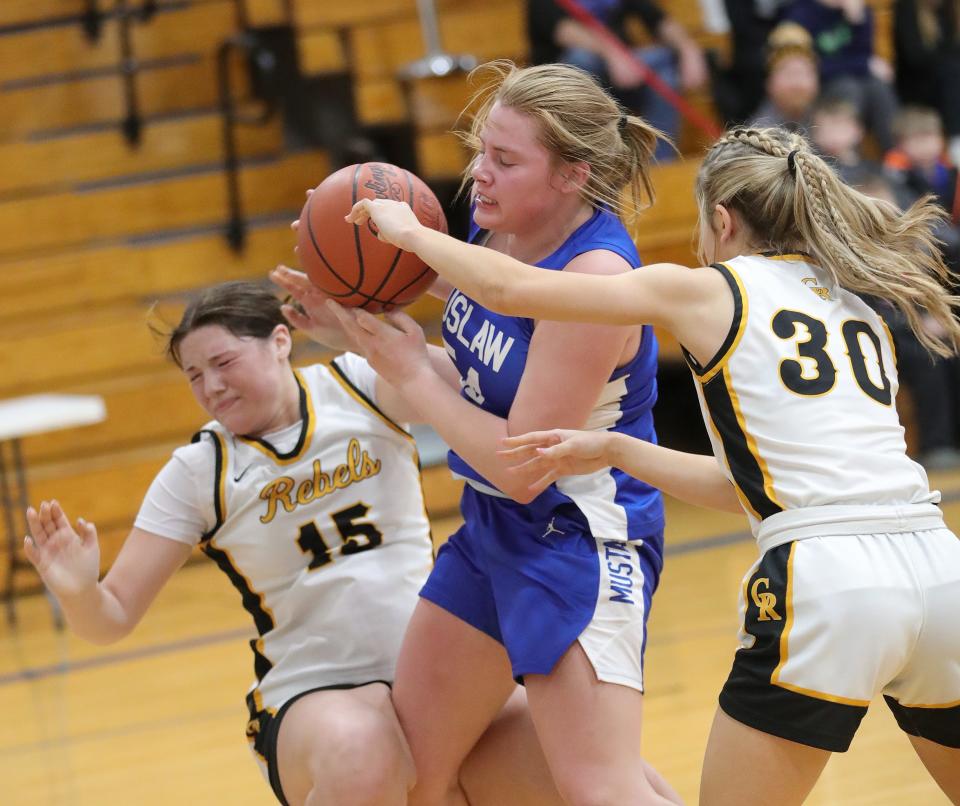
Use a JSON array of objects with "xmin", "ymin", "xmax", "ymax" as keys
[{"xmin": 500, "ymin": 429, "xmax": 743, "ymax": 513}]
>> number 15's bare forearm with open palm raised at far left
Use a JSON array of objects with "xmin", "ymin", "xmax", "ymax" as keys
[{"xmin": 24, "ymin": 501, "xmax": 191, "ymax": 644}]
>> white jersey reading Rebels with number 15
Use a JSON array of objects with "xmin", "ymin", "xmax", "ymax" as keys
[{"xmin": 194, "ymin": 361, "xmax": 433, "ymax": 738}]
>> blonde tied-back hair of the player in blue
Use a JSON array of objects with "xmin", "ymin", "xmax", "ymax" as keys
[{"xmin": 460, "ymin": 60, "xmax": 666, "ymax": 220}]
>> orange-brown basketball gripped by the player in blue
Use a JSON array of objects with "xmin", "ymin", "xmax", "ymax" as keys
[{"xmin": 297, "ymin": 162, "xmax": 447, "ymax": 313}]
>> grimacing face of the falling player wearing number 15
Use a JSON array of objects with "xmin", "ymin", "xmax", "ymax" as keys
[{"xmin": 180, "ymin": 325, "xmax": 299, "ymax": 436}]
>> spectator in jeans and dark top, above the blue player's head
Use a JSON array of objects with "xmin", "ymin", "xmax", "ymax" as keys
[{"xmin": 527, "ymin": 0, "xmax": 708, "ymax": 161}]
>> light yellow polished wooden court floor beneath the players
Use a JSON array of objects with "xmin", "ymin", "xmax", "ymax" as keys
[{"xmin": 0, "ymin": 473, "xmax": 960, "ymax": 806}]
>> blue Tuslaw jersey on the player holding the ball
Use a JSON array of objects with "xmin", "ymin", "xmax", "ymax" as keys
[{"xmin": 443, "ymin": 209, "xmax": 663, "ymax": 539}]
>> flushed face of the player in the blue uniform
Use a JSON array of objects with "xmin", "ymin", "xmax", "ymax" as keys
[{"xmin": 471, "ymin": 104, "xmax": 559, "ymax": 233}]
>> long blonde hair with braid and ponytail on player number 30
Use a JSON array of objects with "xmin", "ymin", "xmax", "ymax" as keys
[{"xmin": 695, "ymin": 128, "xmax": 960, "ymax": 355}]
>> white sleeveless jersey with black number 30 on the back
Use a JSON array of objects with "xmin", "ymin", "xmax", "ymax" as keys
[{"xmin": 687, "ymin": 255, "xmax": 942, "ymax": 548}]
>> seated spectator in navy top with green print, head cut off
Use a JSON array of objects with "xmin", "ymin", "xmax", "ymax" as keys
[{"xmin": 783, "ymin": 0, "xmax": 898, "ymax": 151}]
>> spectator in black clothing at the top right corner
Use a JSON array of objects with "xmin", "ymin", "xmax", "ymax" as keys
[{"xmin": 893, "ymin": 0, "xmax": 960, "ymax": 165}]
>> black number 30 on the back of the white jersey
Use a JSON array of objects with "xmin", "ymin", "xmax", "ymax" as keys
[{"xmin": 771, "ymin": 310, "xmax": 893, "ymax": 406}]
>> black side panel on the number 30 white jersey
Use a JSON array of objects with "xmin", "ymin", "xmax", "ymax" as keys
[{"xmin": 702, "ymin": 370, "xmax": 783, "ymax": 519}]
